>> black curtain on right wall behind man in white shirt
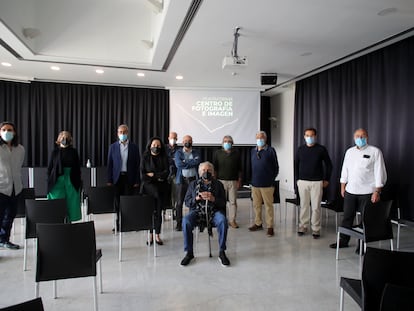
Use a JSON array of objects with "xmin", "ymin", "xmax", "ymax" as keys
[{"xmin": 295, "ymin": 37, "xmax": 414, "ymax": 220}]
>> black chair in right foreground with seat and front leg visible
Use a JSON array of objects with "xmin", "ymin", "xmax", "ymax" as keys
[{"xmin": 339, "ymin": 247, "xmax": 414, "ymax": 311}]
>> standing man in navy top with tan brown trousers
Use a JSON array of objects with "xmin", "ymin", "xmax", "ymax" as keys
[{"xmin": 249, "ymin": 131, "xmax": 279, "ymax": 237}]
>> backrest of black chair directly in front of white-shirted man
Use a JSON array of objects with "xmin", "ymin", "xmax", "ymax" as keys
[{"xmin": 362, "ymin": 201, "xmax": 393, "ymax": 242}]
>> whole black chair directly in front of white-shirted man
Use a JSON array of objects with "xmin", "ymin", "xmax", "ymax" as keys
[{"xmin": 336, "ymin": 201, "xmax": 393, "ymax": 260}]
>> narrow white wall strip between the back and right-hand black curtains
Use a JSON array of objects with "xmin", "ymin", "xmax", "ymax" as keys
[{"xmin": 270, "ymin": 85, "xmax": 295, "ymax": 197}]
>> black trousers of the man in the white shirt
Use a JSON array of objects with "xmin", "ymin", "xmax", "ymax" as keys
[{"xmin": 341, "ymin": 191, "xmax": 372, "ymax": 243}]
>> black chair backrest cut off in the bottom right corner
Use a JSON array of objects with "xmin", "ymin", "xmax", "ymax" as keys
[{"xmin": 380, "ymin": 283, "xmax": 414, "ymax": 311}]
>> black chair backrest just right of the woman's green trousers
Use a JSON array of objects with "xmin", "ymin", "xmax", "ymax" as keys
[{"xmin": 85, "ymin": 186, "xmax": 115, "ymax": 215}]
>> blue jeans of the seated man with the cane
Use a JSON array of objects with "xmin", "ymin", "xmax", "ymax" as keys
[{"xmin": 183, "ymin": 210, "xmax": 229, "ymax": 253}]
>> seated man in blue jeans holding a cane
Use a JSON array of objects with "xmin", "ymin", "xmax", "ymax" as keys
[{"xmin": 181, "ymin": 162, "xmax": 230, "ymax": 267}]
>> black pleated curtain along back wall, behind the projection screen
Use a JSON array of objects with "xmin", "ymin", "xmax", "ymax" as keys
[{"xmin": 0, "ymin": 81, "xmax": 271, "ymax": 183}]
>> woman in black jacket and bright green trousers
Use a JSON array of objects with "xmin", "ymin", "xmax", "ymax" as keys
[{"xmin": 47, "ymin": 131, "xmax": 82, "ymax": 222}]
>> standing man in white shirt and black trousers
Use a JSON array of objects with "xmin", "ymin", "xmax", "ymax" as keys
[{"xmin": 330, "ymin": 129, "xmax": 387, "ymax": 248}]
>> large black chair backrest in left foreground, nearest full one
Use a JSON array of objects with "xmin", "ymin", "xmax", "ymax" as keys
[{"xmin": 36, "ymin": 221, "xmax": 96, "ymax": 282}]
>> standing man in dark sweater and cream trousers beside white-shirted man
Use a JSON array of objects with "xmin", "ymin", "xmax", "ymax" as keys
[{"xmin": 295, "ymin": 128, "xmax": 332, "ymax": 239}]
